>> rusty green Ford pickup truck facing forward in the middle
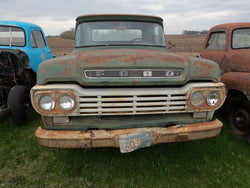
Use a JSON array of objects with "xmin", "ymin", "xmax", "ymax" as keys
[{"xmin": 31, "ymin": 15, "xmax": 225, "ymax": 153}]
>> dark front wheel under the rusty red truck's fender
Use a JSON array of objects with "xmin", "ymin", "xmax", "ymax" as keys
[{"xmin": 225, "ymin": 95, "xmax": 250, "ymax": 141}]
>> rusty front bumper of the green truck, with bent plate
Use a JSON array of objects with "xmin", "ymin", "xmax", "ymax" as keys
[{"xmin": 35, "ymin": 119, "xmax": 223, "ymax": 153}]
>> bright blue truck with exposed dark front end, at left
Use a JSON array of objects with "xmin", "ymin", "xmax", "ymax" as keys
[{"xmin": 0, "ymin": 21, "xmax": 53, "ymax": 124}]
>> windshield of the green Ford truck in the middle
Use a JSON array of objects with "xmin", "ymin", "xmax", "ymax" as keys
[{"xmin": 75, "ymin": 21, "xmax": 165, "ymax": 47}]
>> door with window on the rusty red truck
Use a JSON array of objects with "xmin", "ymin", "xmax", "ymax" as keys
[{"xmin": 201, "ymin": 29, "xmax": 228, "ymax": 65}]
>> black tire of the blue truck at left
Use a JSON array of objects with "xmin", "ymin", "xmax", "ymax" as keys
[{"xmin": 7, "ymin": 86, "xmax": 32, "ymax": 125}]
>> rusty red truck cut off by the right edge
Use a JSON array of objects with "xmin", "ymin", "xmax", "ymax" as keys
[{"xmin": 201, "ymin": 23, "xmax": 250, "ymax": 141}]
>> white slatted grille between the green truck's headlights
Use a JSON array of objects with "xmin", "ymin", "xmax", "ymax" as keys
[{"xmin": 79, "ymin": 88, "xmax": 187, "ymax": 116}]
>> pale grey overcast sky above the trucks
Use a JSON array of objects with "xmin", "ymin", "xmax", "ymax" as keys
[{"xmin": 0, "ymin": 0, "xmax": 250, "ymax": 35}]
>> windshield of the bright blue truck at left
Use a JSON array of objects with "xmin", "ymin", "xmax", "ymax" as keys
[{"xmin": 0, "ymin": 26, "xmax": 25, "ymax": 47}]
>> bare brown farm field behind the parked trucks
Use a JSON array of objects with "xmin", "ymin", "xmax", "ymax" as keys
[{"xmin": 47, "ymin": 35, "xmax": 206, "ymax": 56}]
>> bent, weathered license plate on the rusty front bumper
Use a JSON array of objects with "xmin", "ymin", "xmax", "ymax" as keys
[{"xmin": 119, "ymin": 132, "xmax": 152, "ymax": 153}]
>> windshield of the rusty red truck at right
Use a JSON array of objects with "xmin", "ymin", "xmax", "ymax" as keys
[{"xmin": 232, "ymin": 28, "xmax": 250, "ymax": 49}]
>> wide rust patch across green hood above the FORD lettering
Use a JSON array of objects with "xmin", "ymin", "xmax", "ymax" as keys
[{"xmin": 74, "ymin": 49, "xmax": 187, "ymax": 68}]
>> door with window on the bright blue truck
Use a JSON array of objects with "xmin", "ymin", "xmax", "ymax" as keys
[{"xmin": 30, "ymin": 29, "xmax": 53, "ymax": 72}]
